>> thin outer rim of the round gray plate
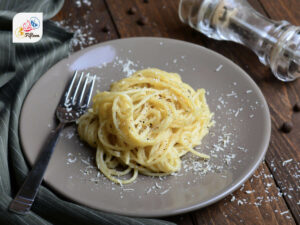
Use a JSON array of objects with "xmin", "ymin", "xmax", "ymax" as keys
[{"xmin": 18, "ymin": 37, "xmax": 271, "ymax": 218}]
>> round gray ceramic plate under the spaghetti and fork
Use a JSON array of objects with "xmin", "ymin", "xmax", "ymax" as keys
[{"xmin": 20, "ymin": 38, "xmax": 271, "ymax": 217}]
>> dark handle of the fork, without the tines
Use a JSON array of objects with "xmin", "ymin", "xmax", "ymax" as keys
[{"xmin": 9, "ymin": 123, "xmax": 65, "ymax": 214}]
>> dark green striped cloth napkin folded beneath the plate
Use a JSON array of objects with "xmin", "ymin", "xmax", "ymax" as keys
[{"xmin": 0, "ymin": 0, "xmax": 172, "ymax": 225}]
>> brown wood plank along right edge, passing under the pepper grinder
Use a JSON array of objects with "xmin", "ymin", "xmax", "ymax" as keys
[{"xmin": 251, "ymin": 0, "xmax": 300, "ymax": 221}]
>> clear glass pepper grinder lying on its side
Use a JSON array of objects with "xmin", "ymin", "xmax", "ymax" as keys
[{"xmin": 179, "ymin": 0, "xmax": 300, "ymax": 82}]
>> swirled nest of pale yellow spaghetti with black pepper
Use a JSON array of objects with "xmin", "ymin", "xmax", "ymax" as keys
[{"xmin": 78, "ymin": 69, "xmax": 213, "ymax": 184}]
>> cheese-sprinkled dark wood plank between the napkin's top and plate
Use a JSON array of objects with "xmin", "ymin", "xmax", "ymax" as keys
[{"xmin": 53, "ymin": 0, "xmax": 118, "ymax": 51}]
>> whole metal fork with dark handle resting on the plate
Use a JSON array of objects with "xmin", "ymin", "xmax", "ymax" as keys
[{"xmin": 9, "ymin": 71, "xmax": 96, "ymax": 214}]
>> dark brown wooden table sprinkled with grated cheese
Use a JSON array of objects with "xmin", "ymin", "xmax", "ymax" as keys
[{"xmin": 54, "ymin": 0, "xmax": 300, "ymax": 225}]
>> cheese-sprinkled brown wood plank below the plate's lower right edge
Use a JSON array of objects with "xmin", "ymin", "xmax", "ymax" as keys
[{"xmin": 194, "ymin": 164, "xmax": 295, "ymax": 225}]
